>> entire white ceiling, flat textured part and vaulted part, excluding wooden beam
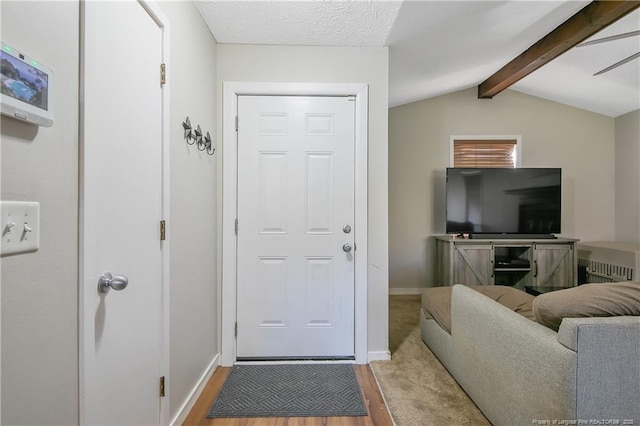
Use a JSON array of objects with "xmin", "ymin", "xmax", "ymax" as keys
[{"xmin": 196, "ymin": 0, "xmax": 640, "ymax": 117}]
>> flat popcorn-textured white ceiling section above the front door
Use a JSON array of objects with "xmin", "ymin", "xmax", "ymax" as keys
[{"xmin": 197, "ymin": 1, "xmax": 402, "ymax": 46}]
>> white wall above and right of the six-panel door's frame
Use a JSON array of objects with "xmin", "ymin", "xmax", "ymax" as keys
[{"xmin": 218, "ymin": 44, "xmax": 389, "ymax": 353}]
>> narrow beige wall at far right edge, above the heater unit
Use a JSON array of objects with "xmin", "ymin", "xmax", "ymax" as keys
[{"xmin": 615, "ymin": 110, "xmax": 640, "ymax": 244}]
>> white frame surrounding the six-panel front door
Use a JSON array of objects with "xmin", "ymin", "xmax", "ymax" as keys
[{"xmin": 218, "ymin": 82, "xmax": 369, "ymax": 366}]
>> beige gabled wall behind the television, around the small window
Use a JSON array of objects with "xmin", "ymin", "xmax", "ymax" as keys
[{"xmin": 389, "ymin": 88, "xmax": 615, "ymax": 291}]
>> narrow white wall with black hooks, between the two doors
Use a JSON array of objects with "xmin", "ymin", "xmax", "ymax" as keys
[{"xmin": 160, "ymin": 1, "xmax": 219, "ymax": 418}]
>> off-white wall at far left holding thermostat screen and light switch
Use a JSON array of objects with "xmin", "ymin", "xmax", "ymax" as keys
[{"xmin": 0, "ymin": 1, "xmax": 79, "ymax": 425}]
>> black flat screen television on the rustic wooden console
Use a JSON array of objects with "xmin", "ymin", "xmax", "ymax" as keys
[{"xmin": 446, "ymin": 168, "xmax": 562, "ymax": 238}]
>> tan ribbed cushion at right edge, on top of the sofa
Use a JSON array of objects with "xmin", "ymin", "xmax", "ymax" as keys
[{"xmin": 532, "ymin": 281, "xmax": 640, "ymax": 331}]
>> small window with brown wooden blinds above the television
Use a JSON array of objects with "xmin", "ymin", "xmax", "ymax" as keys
[{"xmin": 453, "ymin": 139, "xmax": 518, "ymax": 168}]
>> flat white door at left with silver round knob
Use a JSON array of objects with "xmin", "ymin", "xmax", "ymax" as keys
[{"xmin": 81, "ymin": 1, "xmax": 163, "ymax": 425}]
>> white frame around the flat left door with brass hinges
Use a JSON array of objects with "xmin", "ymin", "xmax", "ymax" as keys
[{"xmin": 78, "ymin": 0, "xmax": 171, "ymax": 424}]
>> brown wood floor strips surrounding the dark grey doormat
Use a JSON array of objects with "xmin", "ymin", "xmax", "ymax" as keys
[{"xmin": 183, "ymin": 365, "xmax": 393, "ymax": 426}]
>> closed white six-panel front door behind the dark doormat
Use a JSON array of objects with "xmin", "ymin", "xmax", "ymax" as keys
[{"xmin": 236, "ymin": 96, "xmax": 357, "ymax": 359}]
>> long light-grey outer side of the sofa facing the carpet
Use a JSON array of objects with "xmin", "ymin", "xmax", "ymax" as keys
[{"xmin": 451, "ymin": 285, "xmax": 576, "ymax": 425}]
